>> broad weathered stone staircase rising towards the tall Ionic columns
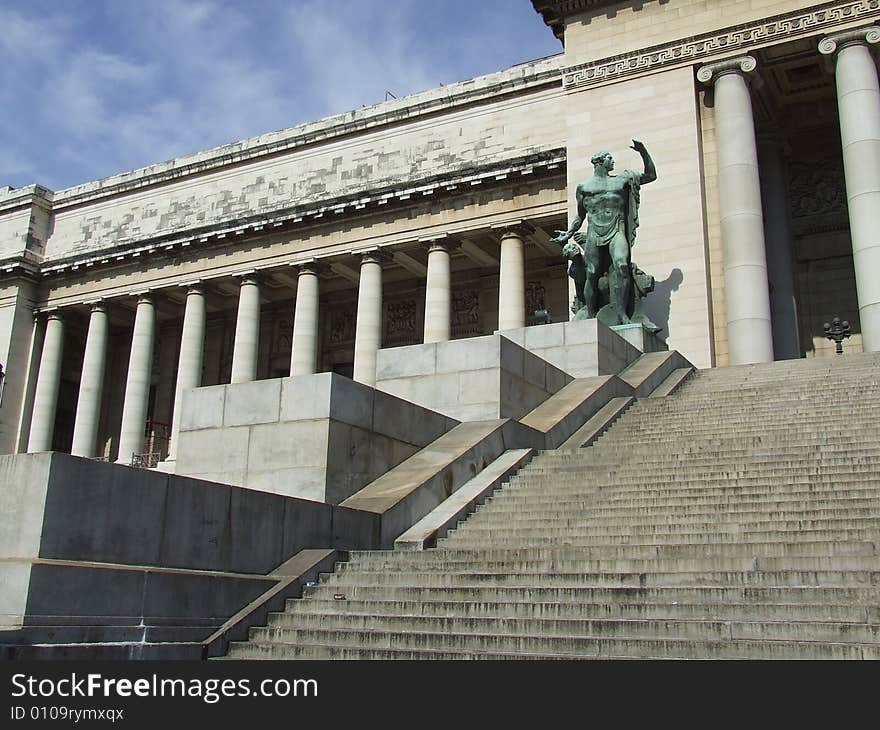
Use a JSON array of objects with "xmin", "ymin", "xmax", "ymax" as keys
[{"xmin": 228, "ymin": 355, "xmax": 880, "ymax": 659}]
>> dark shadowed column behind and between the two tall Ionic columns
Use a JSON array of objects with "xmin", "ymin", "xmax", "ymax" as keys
[{"xmin": 758, "ymin": 132, "xmax": 801, "ymax": 360}]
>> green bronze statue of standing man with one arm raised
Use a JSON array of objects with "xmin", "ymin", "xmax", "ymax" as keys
[{"xmin": 552, "ymin": 139, "xmax": 658, "ymax": 331}]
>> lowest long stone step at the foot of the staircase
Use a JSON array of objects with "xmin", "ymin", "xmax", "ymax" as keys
[{"xmin": 230, "ymin": 629, "xmax": 880, "ymax": 659}]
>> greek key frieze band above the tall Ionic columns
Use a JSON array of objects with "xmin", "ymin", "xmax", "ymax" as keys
[{"xmin": 563, "ymin": 0, "xmax": 880, "ymax": 89}]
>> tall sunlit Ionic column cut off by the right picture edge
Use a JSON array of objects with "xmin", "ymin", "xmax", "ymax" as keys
[{"xmin": 819, "ymin": 26, "xmax": 880, "ymax": 352}]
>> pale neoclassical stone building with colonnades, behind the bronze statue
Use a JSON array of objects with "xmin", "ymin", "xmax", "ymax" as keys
[{"xmin": 0, "ymin": 0, "xmax": 880, "ymax": 464}]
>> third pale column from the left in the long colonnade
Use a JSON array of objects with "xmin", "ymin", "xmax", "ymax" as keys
[{"xmin": 116, "ymin": 293, "xmax": 156, "ymax": 464}]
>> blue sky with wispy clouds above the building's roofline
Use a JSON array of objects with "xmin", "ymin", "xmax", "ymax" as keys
[{"xmin": 0, "ymin": 0, "xmax": 562, "ymax": 190}]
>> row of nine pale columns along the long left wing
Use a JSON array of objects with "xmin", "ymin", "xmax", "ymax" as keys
[{"xmin": 28, "ymin": 228, "xmax": 525, "ymax": 464}]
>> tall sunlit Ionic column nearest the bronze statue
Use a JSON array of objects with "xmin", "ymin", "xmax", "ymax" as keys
[{"xmin": 697, "ymin": 56, "xmax": 773, "ymax": 365}]
